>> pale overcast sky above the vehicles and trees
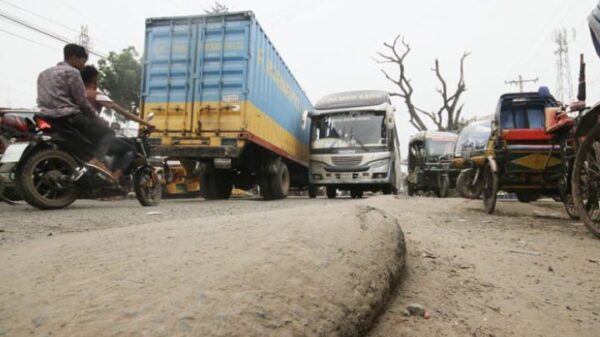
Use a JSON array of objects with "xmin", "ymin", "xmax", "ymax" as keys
[{"xmin": 0, "ymin": 0, "xmax": 600, "ymax": 148}]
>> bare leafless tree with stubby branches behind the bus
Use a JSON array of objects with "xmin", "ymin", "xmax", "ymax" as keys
[{"xmin": 377, "ymin": 35, "xmax": 471, "ymax": 131}]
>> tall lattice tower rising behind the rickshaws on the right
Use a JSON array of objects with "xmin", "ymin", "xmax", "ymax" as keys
[{"xmin": 552, "ymin": 28, "xmax": 575, "ymax": 102}]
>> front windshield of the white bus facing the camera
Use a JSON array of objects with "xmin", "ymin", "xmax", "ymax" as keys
[{"xmin": 310, "ymin": 111, "xmax": 387, "ymax": 151}]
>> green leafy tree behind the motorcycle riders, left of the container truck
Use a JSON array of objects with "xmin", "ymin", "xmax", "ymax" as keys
[{"xmin": 98, "ymin": 47, "xmax": 142, "ymax": 109}]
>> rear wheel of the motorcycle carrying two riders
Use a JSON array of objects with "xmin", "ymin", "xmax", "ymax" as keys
[{"xmin": 16, "ymin": 149, "xmax": 79, "ymax": 209}]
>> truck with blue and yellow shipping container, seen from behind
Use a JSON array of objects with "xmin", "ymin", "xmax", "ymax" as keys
[{"xmin": 142, "ymin": 12, "xmax": 312, "ymax": 199}]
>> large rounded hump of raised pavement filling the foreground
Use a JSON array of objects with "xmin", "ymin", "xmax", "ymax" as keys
[{"xmin": 0, "ymin": 202, "xmax": 406, "ymax": 336}]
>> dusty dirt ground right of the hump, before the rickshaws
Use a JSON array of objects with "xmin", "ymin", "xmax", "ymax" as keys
[{"xmin": 368, "ymin": 197, "xmax": 600, "ymax": 337}]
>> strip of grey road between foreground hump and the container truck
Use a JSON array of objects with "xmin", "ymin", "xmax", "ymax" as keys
[{"xmin": 0, "ymin": 197, "xmax": 336, "ymax": 245}]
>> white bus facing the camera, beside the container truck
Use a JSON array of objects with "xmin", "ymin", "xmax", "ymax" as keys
[{"xmin": 307, "ymin": 90, "xmax": 400, "ymax": 198}]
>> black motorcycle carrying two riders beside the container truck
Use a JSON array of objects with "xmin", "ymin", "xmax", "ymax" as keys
[{"xmin": 0, "ymin": 116, "xmax": 161, "ymax": 209}]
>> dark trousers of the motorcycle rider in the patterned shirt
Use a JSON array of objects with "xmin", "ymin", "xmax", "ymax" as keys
[{"xmin": 51, "ymin": 113, "xmax": 115, "ymax": 160}]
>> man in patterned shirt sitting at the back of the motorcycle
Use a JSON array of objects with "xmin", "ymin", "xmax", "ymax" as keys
[{"xmin": 37, "ymin": 44, "xmax": 115, "ymax": 176}]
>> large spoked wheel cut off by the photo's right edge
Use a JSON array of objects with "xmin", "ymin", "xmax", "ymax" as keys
[{"xmin": 571, "ymin": 125, "xmax": 600, "ymax": 238}]
